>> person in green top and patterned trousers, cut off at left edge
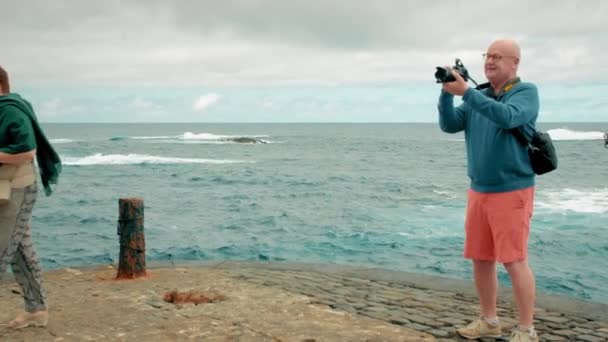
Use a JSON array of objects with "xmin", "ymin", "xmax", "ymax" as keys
[{"xmin": 0, "ymin": 67, "xmax": 61, "ymax": 329}]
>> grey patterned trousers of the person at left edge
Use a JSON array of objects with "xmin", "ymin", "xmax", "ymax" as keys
[{"xmin": 0, "ymin": 183, "xmax": 47, "ymax": 312}]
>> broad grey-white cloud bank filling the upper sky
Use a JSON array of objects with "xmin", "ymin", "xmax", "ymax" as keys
[{"xmin": 0, "ymin": 0, "xmax": 608, "ymax": 87}]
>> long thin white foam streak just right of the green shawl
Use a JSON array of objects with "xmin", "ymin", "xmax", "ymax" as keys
[{"xmin": 63, "ymin": 153, "xmax": 248, "ymax": 166}]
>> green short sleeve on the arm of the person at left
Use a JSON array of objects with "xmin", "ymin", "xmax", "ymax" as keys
[{"xmin": 0, "ymin": 106, "xmax": 36, "ymax": 154}]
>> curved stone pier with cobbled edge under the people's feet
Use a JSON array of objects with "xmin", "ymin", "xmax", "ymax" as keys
[{"xmin": 0, "ymin": 262, "xmax": 608, "ymax": 342}]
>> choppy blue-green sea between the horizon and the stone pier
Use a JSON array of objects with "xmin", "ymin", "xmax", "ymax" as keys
[{"xmin": 33, "ymin": 123, "xmax": 608, "ymax": 303}]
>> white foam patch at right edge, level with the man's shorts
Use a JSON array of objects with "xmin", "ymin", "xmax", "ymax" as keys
[{"xmin": 535, "ymin": 188, "xmax": 608, "ymax": 214}]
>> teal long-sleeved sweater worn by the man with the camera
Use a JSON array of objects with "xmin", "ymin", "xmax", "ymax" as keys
[{"xmin": 438, "ymin": 82, "xmax": 539, "ymax": 192}]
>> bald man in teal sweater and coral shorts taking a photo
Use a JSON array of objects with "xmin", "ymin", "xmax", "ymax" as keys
[{"xmin": 438, "ymin": 40, "xmax": 539, "ymax": 341}]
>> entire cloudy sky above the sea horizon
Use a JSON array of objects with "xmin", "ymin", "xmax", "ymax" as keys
[{"xmin": 0, "ymin": 0, "xmax": 608, "ymax": 122}]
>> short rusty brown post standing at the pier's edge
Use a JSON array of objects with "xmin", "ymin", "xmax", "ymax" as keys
[{"xmin": 116, "ymin": 198, "xmax": 146, "ymax": 279}]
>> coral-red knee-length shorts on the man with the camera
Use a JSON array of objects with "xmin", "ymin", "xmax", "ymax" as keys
[{"xmin": 464, "ymin": 187, "xmax": 534, "ymax": 263}]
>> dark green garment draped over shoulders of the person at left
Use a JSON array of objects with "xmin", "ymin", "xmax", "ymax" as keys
[{"xmin": 0, "ymin": 93, "xmax": 61, "ymax": 196}]
